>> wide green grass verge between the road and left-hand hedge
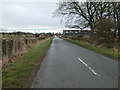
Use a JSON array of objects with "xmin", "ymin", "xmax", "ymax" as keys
[{"xmin": 2, "ymin": 38, "xmax": 52, "ymax": 88}]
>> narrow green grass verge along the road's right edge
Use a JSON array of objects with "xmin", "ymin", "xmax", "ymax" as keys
[{"xmin": 63, "ymin": 38, "xmax": 120, "ymax": 60}]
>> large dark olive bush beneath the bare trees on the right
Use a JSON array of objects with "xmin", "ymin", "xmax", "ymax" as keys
[{"xmin": 94, "ymin": 19, "xmax": 115, "ymax": 48}]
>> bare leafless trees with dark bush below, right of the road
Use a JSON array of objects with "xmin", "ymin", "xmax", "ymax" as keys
[{"xmin": 55, "ymin": 0, "xmax": 120, "ymax": 47}]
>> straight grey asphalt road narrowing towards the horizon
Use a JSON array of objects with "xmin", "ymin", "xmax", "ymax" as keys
[{"xmin": 31, "ymin": 37, "xmax": 118, "ymax": 88}]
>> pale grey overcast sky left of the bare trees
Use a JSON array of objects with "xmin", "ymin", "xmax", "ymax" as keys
[{"xmin": 0, "ymin": 2, "xmax": 64, "ymax": 32}]
